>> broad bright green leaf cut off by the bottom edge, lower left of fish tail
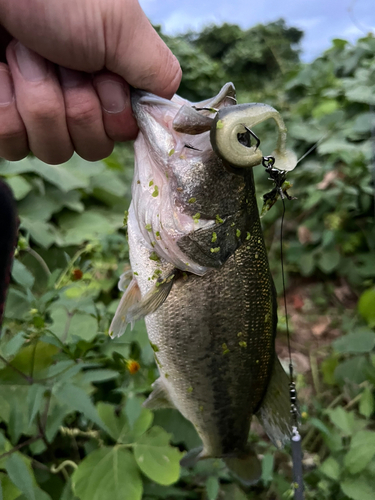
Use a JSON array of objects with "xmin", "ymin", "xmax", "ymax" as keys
[{"xmin": 72, "ymin": 446, "xmax": 142, "ymax": 500}]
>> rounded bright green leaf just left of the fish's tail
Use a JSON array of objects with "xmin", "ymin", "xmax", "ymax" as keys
[{"xmin": 134, "ymin": 426, "xmax": 183, "ymax": 485}]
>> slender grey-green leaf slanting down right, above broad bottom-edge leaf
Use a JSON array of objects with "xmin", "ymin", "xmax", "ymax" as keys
[{"xmin": 54, "ymin": 383, "xmax": 110, "ymax": 434}]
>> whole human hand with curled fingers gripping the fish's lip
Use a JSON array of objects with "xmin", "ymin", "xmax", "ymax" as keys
[{"xmin": 0, "ymin": 0, "xmax": 181, "ymax": 164}]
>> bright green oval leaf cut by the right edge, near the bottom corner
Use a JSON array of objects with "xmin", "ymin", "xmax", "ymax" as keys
[{"xmin": 344, "ymin": 430, "xmax": 375, "ymax": 474}]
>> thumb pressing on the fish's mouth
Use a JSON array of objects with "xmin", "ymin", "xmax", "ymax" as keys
[{"xmin": 103, "ymin": 0, "xmax": 182, "ymax": 98}]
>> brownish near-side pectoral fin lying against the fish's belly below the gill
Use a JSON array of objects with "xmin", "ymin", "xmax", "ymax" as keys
[{"xmin": 128, "ymin": 273, "xmax": 175, "ymax": 322}]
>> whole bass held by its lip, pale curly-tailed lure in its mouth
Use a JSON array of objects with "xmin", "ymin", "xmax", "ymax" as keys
[{"xmin": 109, "ymin": 83, "xmax": 295, "ymax": 484}]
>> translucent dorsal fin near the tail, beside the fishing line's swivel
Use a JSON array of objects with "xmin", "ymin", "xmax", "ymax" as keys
[{"xmin": 255, "ymin": 356, "xmax": 292, "ymax": 448}]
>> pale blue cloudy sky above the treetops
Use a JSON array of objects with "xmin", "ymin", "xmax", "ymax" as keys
[{"xmin": 139, "ymin": 0, "xmax": 375, "ymax": 62}]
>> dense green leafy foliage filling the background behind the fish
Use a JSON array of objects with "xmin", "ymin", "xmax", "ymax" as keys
[{"xmin": 0, "ymin": 20, "xmax": 375, "ymax": 500}]
